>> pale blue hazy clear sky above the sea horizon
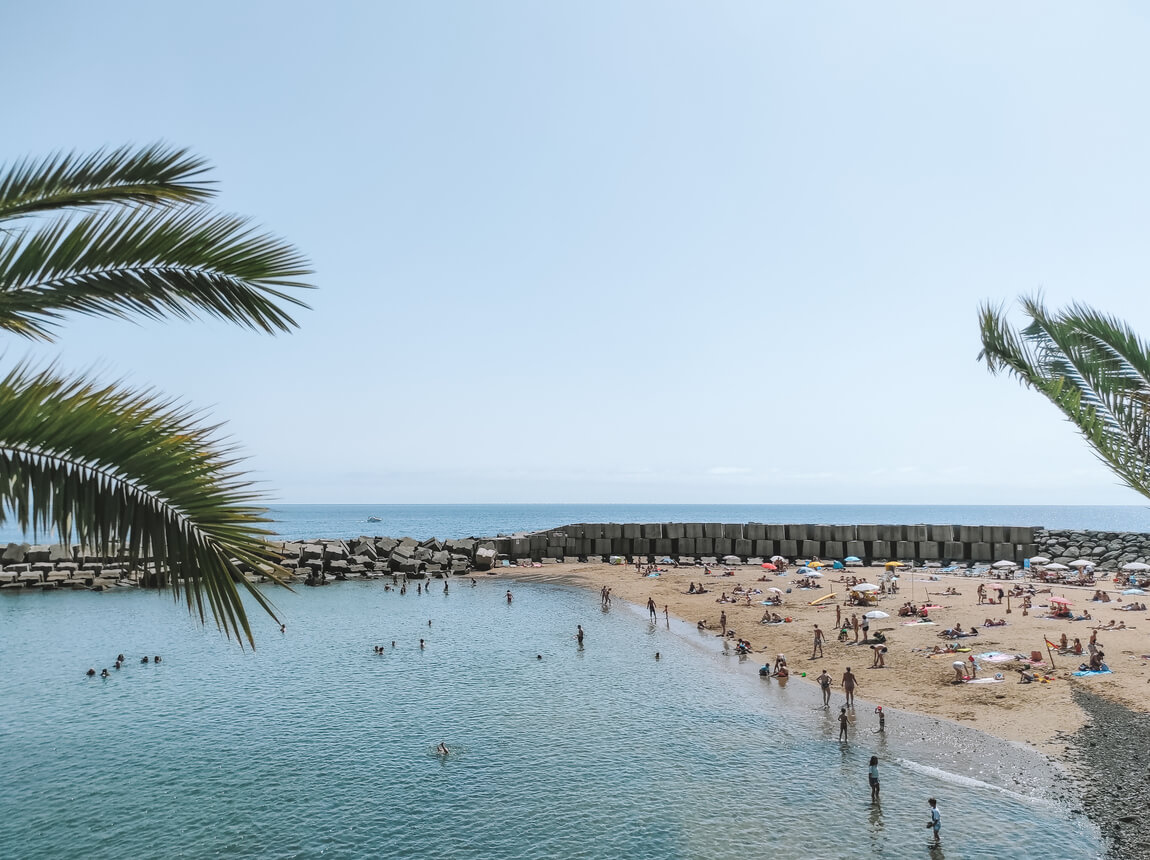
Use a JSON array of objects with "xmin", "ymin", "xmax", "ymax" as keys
[{"xmin": 0, "ymin": 0, "xmax": 1150, "ymax": 505}]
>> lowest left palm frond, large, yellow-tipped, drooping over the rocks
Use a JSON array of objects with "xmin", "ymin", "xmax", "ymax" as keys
[{"xmin": 0, "ymin": 364, "xmax": 285, "ymax": 646}]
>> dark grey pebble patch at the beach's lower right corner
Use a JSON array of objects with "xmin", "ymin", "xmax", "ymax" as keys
[{"xmin": 1066, "ymin": 689, "xmax": 1150, "ymax": 859}]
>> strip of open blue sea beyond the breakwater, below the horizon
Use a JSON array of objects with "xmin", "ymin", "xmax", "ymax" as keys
[{"xmin": 0, "ymin": 505, "xmax": 1150, "ymax": 543}]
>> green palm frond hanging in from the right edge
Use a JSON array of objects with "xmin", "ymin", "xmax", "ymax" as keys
[{"xmin": 979, "ymin": 298, "xmax": 1150, "ymax": 497}]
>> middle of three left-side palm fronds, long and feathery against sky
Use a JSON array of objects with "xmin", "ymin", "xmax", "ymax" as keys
[{"xmin": 0, "ymin": 207, "xmax": 311, "ymax": 340}]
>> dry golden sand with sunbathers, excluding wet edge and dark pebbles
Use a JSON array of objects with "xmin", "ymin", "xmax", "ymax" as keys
[{"xmin": 501, "ymin": 563, "xmax": 1150, "ymax": 759}]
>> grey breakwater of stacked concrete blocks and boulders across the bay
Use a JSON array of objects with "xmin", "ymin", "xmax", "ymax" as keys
[{"xmin": 0, "ymin": 523, "xmax": 1150, "ymax": 590}]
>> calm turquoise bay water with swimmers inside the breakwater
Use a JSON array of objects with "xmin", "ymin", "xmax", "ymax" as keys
[{"xmin": 0, "ymin": 577, "xmax": 1101, "ymax": 860}]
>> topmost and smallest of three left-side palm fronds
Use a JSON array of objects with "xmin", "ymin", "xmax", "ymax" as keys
[{"xmin": 0, "ymin": 144, "xmax": 214, "ymax": 221}]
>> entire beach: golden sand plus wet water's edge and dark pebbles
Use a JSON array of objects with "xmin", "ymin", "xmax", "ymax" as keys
[{"xmin": 491, "ymin": 565, "xmax": 1150, "ymax": 855}]
